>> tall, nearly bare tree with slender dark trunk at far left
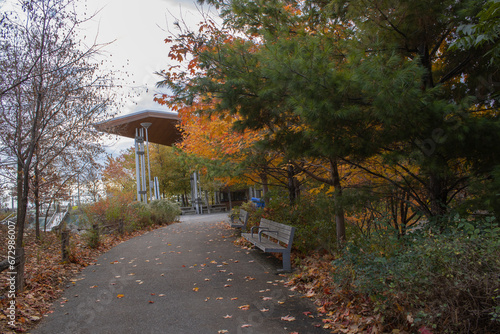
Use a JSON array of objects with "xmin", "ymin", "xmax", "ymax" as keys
[{"xmin": 0, "ymin": 0, "xmax": 115, "ymax": 290}]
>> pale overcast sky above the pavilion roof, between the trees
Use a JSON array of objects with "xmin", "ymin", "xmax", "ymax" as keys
[{"xmin": 82, "ymin": 0, "xmax": 216, "ymax": 155}]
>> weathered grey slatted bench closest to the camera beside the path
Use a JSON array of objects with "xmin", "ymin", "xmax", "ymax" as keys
[{"xmin": 241, "ymin": 218, "xmax": 295, "ymax": 271}]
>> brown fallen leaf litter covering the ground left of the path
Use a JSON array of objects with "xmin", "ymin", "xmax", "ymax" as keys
[{"xmin": 0, "ymin": 225, "xmax": 164, "ymax": 334}]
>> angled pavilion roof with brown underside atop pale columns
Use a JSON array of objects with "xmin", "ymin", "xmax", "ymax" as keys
[{"xmin": 94, "ymin": 110, "xmax": 181, "ymax": 146}]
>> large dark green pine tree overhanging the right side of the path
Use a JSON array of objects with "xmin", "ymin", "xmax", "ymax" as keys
[{"xmin": 160, "ymin": 0, "xmax": 500, "ymax": 240}]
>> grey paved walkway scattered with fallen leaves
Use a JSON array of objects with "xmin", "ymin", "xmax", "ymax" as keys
[{"xmin": 31, "ymin": 214, "xmax": 327, "ymax": 334}]
